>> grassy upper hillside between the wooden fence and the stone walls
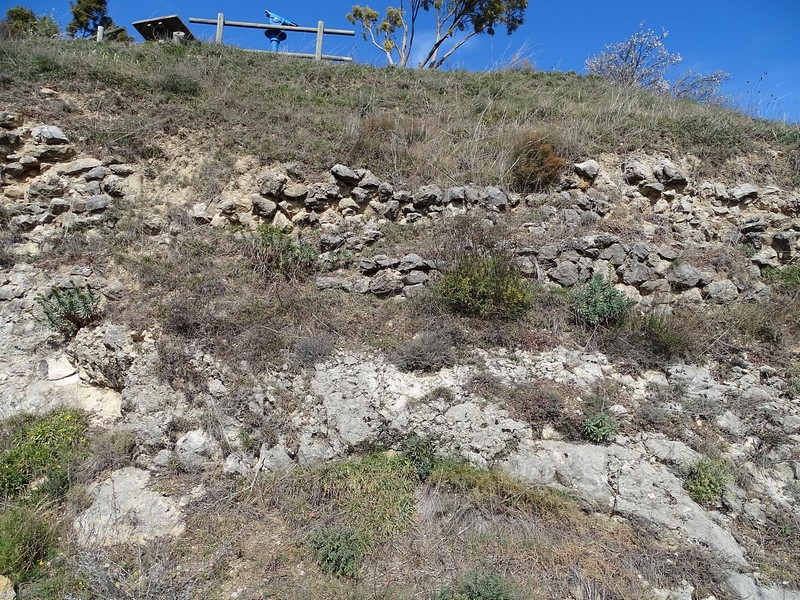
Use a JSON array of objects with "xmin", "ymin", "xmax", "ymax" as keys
[{"xmin": 0, "ymin": 40, "xmax": 800, "ymax": 184}]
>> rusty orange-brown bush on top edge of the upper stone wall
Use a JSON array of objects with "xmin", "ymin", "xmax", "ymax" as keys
[{"xmin": 511, "ymin": 131, "xmax": 567, "ymax": 193}]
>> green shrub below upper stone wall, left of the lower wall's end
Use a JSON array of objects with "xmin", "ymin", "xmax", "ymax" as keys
[{"xmin": 245, "ymin": 225, "xmax": 317, "ymax": 280}]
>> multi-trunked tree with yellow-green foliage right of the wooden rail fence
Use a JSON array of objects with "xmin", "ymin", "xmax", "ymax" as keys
[{"xmin": 347, "ymin": 0, "xmax": 528, "ymax": 69}]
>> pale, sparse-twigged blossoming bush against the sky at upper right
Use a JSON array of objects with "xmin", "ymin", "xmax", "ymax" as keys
[{"xmin": 586, "ymin": 23, "xmax": 729, "ymax": 102}]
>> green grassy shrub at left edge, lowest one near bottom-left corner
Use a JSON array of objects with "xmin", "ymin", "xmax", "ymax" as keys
[{"xmin": 0, "ymin": 505, "xmax": 55, "ymax": 582}]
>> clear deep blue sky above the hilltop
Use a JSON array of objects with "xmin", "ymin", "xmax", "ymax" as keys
[{"xmin": 6, "ymin": 0, "xmax": 800, "ymax": 122}]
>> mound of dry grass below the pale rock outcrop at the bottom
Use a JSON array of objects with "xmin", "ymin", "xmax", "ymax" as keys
[{"xmin": 122, "ymin": 463, "xmax": 721, "ymax": 600}]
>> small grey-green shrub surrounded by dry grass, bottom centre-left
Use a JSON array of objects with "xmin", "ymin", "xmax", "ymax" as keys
[{"xmin": 308, "ymin": 527, "xmax": 371, "ymax": 579}]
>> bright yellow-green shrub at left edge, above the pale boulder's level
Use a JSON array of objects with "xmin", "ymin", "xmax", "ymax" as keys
[{"xmin": 0, "ymin": 409, "xmax": 87, "ymax": 498}]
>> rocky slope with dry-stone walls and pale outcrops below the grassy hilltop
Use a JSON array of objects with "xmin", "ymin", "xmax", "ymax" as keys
[{"xmin": 0, "ymin": 38, "xmax": 800, "ymax": 599}]
